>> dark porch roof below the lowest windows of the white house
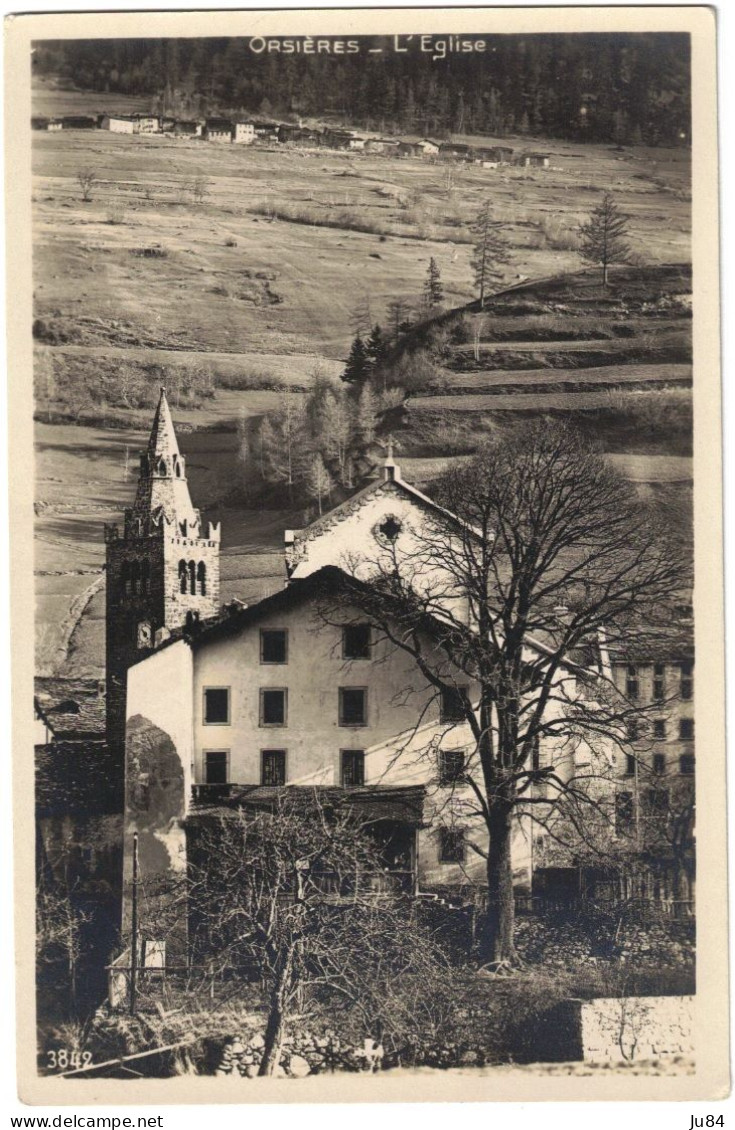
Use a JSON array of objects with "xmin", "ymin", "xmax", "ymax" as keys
[{"xmin": 189, "ymin": 784, "xmax": 425, "ymax": 825}]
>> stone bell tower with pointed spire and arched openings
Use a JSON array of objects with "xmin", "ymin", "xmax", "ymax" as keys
[{"xmin": 105, "ymin": 389, "xmax": 221, "ymax": 753}]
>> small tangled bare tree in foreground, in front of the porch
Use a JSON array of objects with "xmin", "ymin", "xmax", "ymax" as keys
[{"xmin": 183, "ymin": 789, "xmax": 451, "ymax": 1076}]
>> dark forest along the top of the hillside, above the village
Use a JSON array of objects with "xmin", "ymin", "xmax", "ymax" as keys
[{"xmin": 33, "ymin": 33, "xmax": 690, "ymax": 146}]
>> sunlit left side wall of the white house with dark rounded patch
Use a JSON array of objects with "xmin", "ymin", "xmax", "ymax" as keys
[{"xmin": 123, "ymin": 641, "xmax": 192, "ymax": 955}]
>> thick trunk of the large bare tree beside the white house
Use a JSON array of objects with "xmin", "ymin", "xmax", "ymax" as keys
[{"xmin": 481, "ymin": 800, "xmax": 518, "ymax": 965}]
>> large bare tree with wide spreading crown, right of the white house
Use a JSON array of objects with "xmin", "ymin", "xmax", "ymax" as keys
[{"xmin": 322, "ymin": 423, "xmax": 688, "ymax": 964}]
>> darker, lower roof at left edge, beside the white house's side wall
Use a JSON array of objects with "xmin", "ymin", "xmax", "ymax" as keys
[{"xmin": 35, "ymin": 740, "xmax": 124, "ymax": 817}]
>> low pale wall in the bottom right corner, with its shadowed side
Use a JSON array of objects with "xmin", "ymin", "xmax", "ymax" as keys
[{"xmin": 533, "ymin": 997, "xmax": 694, "ymax": 1063}]
